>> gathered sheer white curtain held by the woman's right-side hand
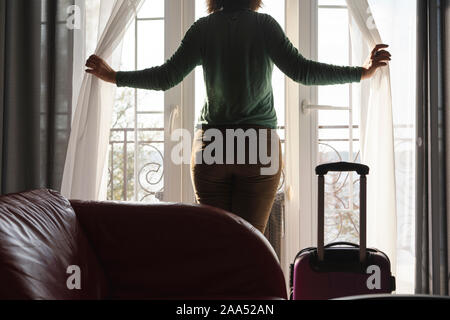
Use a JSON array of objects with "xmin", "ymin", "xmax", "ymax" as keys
[{"xmin": 346, "ymin": 0, "xmax": 397, "ymax": 273}]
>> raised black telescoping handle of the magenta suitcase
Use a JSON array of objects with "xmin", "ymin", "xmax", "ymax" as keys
[{"xmin": 316, "ymin": 162, "xmax": 369, "ymax": 263}]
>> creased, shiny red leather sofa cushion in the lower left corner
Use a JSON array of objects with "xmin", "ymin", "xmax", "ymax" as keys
[{"xmin": 0, "ymin": 189, "xmax": 106, "ymax": 299}]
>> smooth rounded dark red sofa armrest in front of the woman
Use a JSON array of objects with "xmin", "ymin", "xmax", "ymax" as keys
[{"xmin": 71, "ymin": 200, "xmax": 287, "ymax": 299}]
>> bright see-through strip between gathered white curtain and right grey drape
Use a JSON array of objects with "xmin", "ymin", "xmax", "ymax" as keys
[{"xmin": 369, "ymin": 0, "xmax": 417, "ymax": 293}]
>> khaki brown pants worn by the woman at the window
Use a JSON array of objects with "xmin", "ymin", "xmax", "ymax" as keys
[{"xmin": 191, "ymin": 126, "xmax": 282, "ymax": 233}]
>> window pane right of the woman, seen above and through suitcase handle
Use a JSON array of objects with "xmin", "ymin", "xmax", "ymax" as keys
[{"xmin": 318, "ymin": 1, "xmax": 359, "ymax": 243}]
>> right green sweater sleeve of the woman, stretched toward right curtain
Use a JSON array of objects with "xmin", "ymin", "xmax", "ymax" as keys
[{"xmin": 264, "ymin": 15, "xmax": 363, "ymax": 85}]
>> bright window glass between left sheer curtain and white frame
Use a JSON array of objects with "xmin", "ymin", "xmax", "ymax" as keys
[{"xmin": 108, "ymin": 0, "xmax": 165, "ymax": 202}]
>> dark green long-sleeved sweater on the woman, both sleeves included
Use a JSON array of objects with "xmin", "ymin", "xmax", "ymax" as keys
[{"xmin": 116, "ymin": 9, "xmax": 362, "ymax": 128}]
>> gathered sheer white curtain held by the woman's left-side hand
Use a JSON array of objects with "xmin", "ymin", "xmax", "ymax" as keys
[{"xmin": 61, "ymin": 0, "xmax": 143, "ymax": 200}]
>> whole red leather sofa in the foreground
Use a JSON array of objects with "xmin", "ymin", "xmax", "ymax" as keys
[{"xmin": 0, "ymin": 189, "xmax": 287, "ymax": 300}]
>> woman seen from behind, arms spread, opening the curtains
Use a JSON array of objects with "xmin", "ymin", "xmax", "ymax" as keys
[{"xmin": 86, "ymin": 0, "xmax": 391, "ymax": 232}]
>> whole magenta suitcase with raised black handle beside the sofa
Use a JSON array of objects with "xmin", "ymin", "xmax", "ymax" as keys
[{"xmin": 290, "ymin": 162, "xmax": 395, "ymax": 300}]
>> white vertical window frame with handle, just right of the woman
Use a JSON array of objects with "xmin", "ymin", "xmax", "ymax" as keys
[{"xmin": 285, "ymin": 0, "xmax": 318, "ymax": 268}]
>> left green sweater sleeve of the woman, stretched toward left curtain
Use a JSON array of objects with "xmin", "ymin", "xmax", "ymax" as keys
[{"xmin": 116, "ymin": 19, "xmax": 202, "ymax": 91}]
